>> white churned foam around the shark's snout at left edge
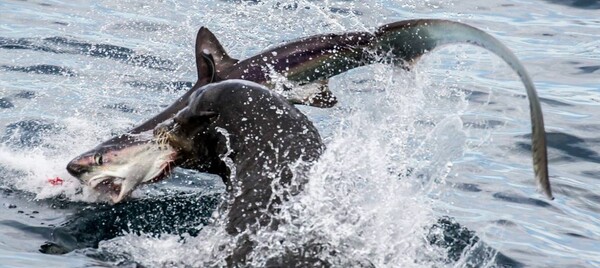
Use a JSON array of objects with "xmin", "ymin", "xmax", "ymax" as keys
[{"xmin": 0, "ymin": 118, "xmax": 135, "ymax": 202}]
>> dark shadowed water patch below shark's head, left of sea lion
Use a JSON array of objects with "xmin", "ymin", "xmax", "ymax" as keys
[{"xmin": 40, "ymin": 193, "xmax": 220, "ymax": 254}]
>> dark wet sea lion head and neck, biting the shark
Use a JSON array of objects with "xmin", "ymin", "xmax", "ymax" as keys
[{"xmin": 155, "ymin": 80, "xmax": 324, "ymax": 265}]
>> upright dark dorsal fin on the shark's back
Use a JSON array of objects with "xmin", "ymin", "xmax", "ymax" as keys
[{"xmin": 196, "ymin": 27, "xmax": 238, "ymax": 73}]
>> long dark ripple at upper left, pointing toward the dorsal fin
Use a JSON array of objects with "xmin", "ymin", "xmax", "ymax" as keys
[{"xmin": 0, "ymin": 36, "xmax": 175, "ymax": 71}]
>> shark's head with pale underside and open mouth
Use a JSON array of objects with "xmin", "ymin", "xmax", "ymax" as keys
[{"xmin": 67, "ymin": 135, "xmax": 177, "ymax": 203}]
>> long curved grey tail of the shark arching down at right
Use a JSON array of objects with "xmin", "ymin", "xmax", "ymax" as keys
[{"xmin": 371, "ymin": 19, "xmax": 553, "ymax": 199}]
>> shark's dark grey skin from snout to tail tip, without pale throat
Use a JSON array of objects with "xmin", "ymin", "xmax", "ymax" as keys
[{"xmin": 67, "ymin": 19, "xmax": 553, "ymax": 202}]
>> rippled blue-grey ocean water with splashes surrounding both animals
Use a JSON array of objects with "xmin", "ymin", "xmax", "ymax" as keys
[{"xmin": 0, "ymin": 0, "xmax": 600, "ymax": 267}]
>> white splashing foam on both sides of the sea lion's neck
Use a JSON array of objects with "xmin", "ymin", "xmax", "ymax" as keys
[{"xmin": 97, "ymin": 62, "xmax": 465, "ymax": 267}]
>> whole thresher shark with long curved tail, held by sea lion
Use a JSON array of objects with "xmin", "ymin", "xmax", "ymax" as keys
[{"xmin": 67, "ymin": 19, "xmax": 553, "ymax": 203}]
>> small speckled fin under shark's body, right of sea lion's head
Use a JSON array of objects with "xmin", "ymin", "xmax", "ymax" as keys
[{"xmin": 283, "ymin": 80, "xmax": 337, "ymax": 108}]
